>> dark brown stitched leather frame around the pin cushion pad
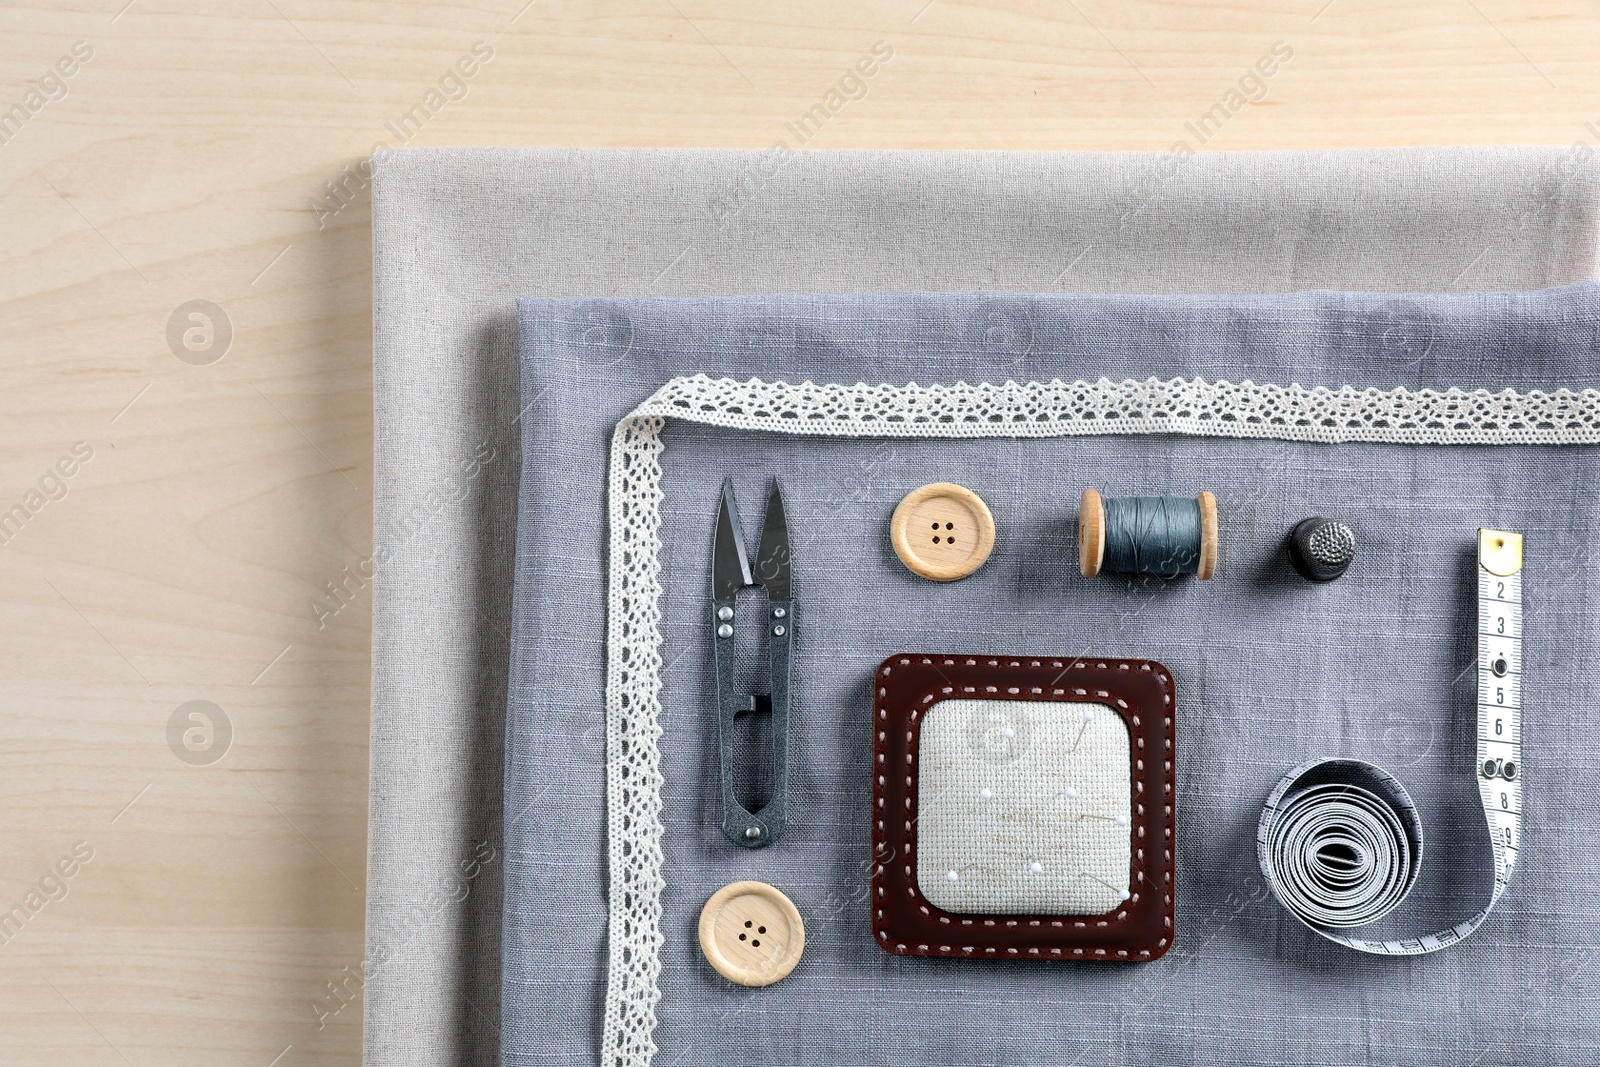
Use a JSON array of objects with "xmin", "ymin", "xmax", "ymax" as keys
[{"xmin": 872, "ymin": 654, "xmax": 1176, "ymax": 961}]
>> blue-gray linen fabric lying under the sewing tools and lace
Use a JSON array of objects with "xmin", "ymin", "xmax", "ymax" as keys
[{"xmin": 502, "ymin": 285, "xmax": 1600, "ymax": 1067}]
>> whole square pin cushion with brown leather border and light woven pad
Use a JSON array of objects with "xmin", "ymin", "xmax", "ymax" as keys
[{"xmin": 870, "ymin": 654, "xmax": 1176, "ymax": 961}]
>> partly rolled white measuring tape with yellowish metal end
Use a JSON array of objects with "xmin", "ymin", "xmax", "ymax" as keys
[{"xmin": 1256, "ymin": 530, "xmax": 1522, "ymax": 955}]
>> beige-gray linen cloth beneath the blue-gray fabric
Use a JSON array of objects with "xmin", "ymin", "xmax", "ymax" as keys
[{"xmin": 365, "ymin": 149, "xmax": 1600, "ymax": 1067}]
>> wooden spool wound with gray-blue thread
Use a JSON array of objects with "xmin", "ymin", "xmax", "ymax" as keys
[{"xmin": 1078, "ymin": 490, "xmax": 1218, "ymax": 579}]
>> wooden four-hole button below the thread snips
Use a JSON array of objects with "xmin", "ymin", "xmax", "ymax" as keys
[{"xmin": 701, "ymin": 881, "xmax": 805, "ymax": 985}]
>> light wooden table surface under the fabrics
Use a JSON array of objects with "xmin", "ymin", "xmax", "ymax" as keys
[{"xmin": 0, "ymin": 0, "xmax": 1600, "ymax": 1067}]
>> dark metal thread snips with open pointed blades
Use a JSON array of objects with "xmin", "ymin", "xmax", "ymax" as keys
[{"xmin": 710, "ymin": 478, "xmax": 795, "ymax": 848}]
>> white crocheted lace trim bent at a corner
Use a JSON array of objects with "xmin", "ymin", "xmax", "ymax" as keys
[{"xmin": 602, "ymin": 374, "xmax": 1600, "ymax": 1067}]
